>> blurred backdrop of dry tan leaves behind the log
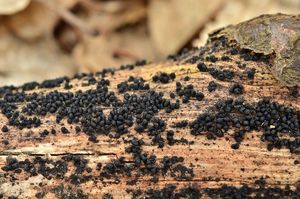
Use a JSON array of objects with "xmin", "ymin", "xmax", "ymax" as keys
[{"xmin": 0, "ymin": 0, "xmax": 300, "ymax": 86}]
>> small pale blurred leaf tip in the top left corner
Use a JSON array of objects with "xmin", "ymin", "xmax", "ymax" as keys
[{"xmin": 0, "ymin": 0, "xmax": 30, "ymax": 15}]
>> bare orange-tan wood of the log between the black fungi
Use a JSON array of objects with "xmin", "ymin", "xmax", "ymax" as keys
[{"xmin": 0, "ymin": 14, "xmax": 300, "ymax": 198}]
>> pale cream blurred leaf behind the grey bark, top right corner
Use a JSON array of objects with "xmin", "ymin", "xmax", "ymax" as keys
[{"xmin": 194, "ymin": 0, "xmax": 300, "ymax": 46}]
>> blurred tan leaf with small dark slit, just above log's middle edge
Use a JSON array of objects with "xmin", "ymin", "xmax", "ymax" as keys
[{"xmin": 73, "ymin": 25, "xmax": 156, "ymax": 72}]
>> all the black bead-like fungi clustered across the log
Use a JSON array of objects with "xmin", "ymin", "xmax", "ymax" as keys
[{"xmin": 0, "ymin": 36, "xmax": 300, "ymax": 199}]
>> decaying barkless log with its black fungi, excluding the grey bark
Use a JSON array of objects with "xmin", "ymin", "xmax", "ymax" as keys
[{"xmin": 0, "ymin": 13, "xmax": 300, "ymax": 198}]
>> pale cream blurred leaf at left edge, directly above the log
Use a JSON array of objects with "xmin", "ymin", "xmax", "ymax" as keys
[{"xmin": 0, "ymin": 26, "xmax": 76, "ymax": 85}]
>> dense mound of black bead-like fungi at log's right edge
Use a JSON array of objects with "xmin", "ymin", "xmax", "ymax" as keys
[{"xmin": 190, "ymin": 99, "xmax": 300, "ymax": 153}]
